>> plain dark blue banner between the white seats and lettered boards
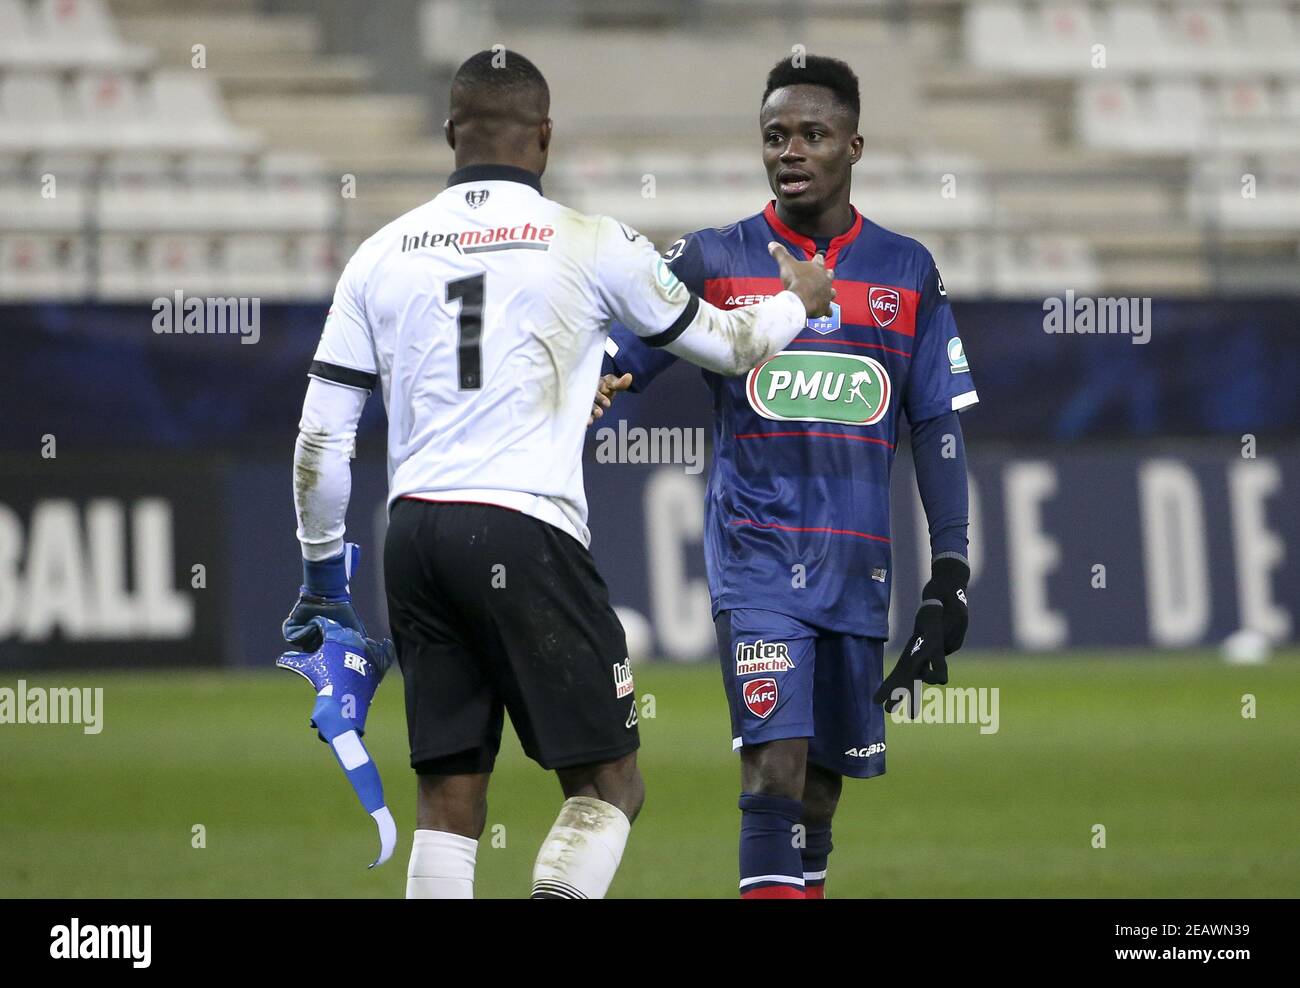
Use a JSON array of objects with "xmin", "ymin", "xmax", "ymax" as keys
[{"xmin": 0, "ymin": 299, "xmax": 1300, "ymax": 451}]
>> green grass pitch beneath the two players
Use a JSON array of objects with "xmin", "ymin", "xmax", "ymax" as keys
[{"xmin": 0, "ymin": 651, "xmax": 1300, "ymax": 898}]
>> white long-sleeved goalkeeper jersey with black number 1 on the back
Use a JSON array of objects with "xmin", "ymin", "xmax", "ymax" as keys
[{"xmin": 294, "ymin": 165, "xmax": 807, "ymax": 559}]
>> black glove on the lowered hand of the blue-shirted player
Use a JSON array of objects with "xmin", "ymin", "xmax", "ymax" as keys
[{"xmin": 875, "ymin": 556, "xmax": 971, "ymax": 716}]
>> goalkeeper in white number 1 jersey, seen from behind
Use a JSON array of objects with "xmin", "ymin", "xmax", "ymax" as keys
[{"xmin": 285, "ymin": 51, "xmax": 835, "ymax": 898}]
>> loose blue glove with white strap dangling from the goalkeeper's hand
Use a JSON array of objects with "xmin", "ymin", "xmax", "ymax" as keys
[{"xmin": 276, "ymin": 618, "xmax": 398, "ymax": 868}]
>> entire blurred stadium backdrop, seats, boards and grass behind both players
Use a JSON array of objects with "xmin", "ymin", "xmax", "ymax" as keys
[{"xmin": 0, "ymin": 0, "xmax": 1300, "ymax": 897}]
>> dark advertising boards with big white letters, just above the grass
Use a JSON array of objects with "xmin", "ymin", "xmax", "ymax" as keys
[{"xmin": 0, "ymin": 441, "xmax": 1300, "ymax": 670}]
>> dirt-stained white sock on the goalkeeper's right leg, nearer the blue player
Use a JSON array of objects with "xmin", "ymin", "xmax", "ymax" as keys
[{"xmin": 533, "ymin": 796, "xmax": 632, "ymax": 898}]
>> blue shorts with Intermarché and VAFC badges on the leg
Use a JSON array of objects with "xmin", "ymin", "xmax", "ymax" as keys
[{"xmin": 714, "ymin": 607, "xmax": 885, "ymax": 779}]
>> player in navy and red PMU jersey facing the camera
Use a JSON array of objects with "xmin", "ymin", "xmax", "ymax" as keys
[{"xmin": 593, "ymin": 56, "xmax": 978, "ymax": 898}]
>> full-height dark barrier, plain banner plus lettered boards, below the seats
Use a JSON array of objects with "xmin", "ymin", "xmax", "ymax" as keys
[{"xmin": 0, "ymin": 299, "xmax": 1300, "ymax": 668}]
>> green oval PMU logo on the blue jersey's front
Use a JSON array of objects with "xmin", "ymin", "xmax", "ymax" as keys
[{"xmin": 745, "ymin": 350, "xmax": 893, "ymax": 425}]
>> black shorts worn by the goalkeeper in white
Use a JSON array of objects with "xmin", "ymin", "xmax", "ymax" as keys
[{"xmin": 384, "ymin": 498, "xmax": 640, "ymax": 775}]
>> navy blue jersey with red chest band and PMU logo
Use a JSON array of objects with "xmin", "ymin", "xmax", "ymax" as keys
[{"xmin": 605, "ymin": 203, "xmax": 978, "ymax": 638}]
